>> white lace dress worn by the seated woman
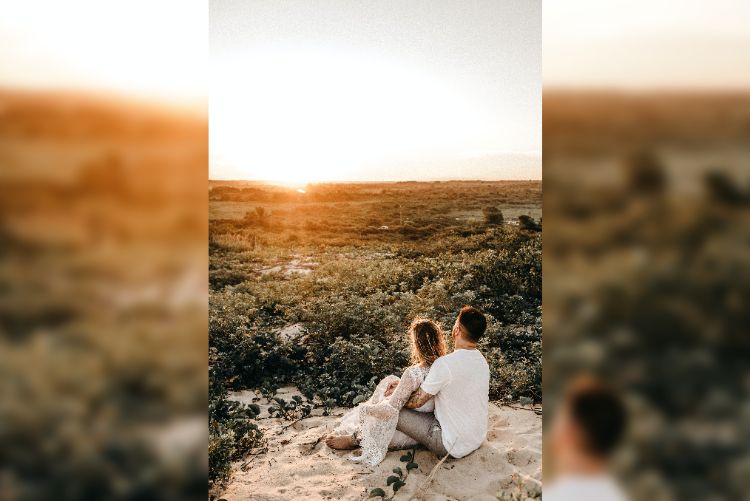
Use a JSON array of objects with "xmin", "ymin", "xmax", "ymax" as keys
[{"xmin": 333, "ymin": 365, "xmax": 435, "ymax": 466}]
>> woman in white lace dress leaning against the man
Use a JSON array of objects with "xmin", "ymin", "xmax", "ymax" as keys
[{"xmin": 326, "ymin": 318, "xmax": 446, "ymax": 466}]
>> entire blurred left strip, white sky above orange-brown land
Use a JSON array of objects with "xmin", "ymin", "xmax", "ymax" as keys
[{"xmin": 0, "ymin": 0, "xmax": 208, "ymax": 500}]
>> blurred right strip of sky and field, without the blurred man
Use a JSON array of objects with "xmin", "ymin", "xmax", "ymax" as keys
[{"xmin": 543, "ymin": 0, "xmax": 750, "ymax": 500}]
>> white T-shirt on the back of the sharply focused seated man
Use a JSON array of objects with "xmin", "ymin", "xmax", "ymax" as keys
[{"xmin": 422, "ymin": 350, "xmax": 490, "ymax": 458}]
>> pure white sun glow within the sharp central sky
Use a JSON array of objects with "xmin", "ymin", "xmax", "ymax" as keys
[{"xmin": 210, "ymin": 49, "xmax": 498, "ymax": 183}]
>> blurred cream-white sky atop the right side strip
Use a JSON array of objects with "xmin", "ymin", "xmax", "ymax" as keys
[{"xmin": 543, "ymin": 0, "xmax": 750, "ymax": 91}]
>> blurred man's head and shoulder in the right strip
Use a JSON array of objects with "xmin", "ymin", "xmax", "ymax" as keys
[{"xmin": 543, "ymin": 378, "xmax": 626, "ymax": 501}]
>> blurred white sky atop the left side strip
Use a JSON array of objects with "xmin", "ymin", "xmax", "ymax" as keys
[{"xmin": 0, "ymin": 0, "xmax": 208, "ymax": 107}]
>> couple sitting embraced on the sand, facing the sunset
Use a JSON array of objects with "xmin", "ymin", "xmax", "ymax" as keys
[{"xmin": 326, "ymin": 306, "xmax": 490, "ymax": 466}]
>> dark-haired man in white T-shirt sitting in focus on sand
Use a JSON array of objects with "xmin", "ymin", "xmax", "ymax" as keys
[{"xmin": 386, "ymin": 306, "xmax": 490, "ymax": 458}]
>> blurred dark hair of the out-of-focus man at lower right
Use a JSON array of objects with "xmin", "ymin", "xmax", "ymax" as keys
[{"xmin": 568, "ymin": 385, "xmax": 627, "ymax": 458}]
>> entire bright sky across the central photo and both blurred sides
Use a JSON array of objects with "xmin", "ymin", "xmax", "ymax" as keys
[{"xmin": 7, "ymin": 0, "xmax": 750, "ymax": 182}]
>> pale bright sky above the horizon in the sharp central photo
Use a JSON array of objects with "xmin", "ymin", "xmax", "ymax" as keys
[{"xmin": 209, "ymin": 0, "xmax": 542, "ymax": 183}]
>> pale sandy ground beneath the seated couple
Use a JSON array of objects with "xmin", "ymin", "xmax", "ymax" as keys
[{"xmin": 222, "ymin": 388, "xmax": 542, "ymax": 501}]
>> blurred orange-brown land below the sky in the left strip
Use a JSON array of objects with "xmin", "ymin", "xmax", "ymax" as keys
[{"xmin": 0, "ymin": 90, "xmax": 207, "ymax": 500}]
